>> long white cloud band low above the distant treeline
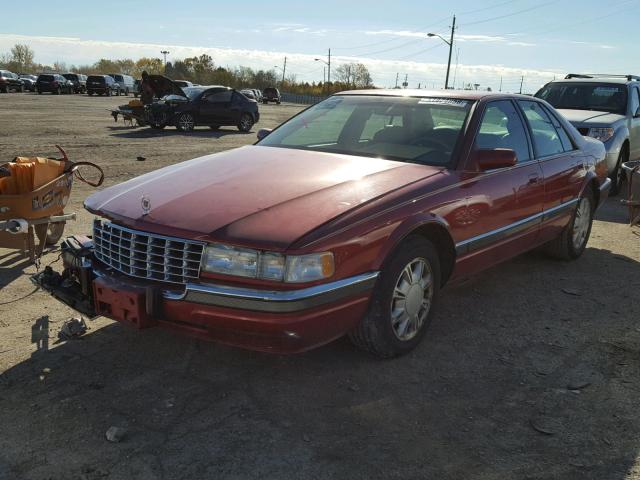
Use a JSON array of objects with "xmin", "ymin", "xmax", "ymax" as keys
[{"xmin": 0, "ymin": 34, "xmax": 560, "ymax": 91}]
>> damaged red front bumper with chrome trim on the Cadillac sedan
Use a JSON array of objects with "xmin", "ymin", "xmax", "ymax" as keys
[{"xmin": 33, "ymin": 237, "xmax": 378, "ymax": 353}]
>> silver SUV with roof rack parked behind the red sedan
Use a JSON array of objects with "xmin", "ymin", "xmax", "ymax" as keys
[{"xmin": 536, "ymin": 73, "xmax": 640, "ymax": 195}]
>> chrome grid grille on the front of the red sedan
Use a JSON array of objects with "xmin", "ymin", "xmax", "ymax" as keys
[{"xmin": 93, "ymin": 219, "xmax": 204, "ymax": 283}]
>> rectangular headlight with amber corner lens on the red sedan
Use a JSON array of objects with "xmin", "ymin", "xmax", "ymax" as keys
[{"xmin": 202, "ymin": 244, "xmax": 335, "ymax": 283}]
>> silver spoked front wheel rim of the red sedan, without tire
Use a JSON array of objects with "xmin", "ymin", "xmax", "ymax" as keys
[{"xmin": 391, "ymin": 258, "xmax": 433, "ymax": 341}]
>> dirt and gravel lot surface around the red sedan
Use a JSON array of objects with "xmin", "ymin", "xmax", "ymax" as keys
[{"xmin": 0, "ymin": 94, "xmax": 640, "ymax": 480}]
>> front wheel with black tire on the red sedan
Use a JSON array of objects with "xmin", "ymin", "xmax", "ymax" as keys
[{"xmin": 349, "ymin": 235, "xmax": 440, "ymax": 358}]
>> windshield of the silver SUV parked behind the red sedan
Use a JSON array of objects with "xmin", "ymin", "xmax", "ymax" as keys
[{"xmin": 536, "ymin": 83, "xmax": 627, "ymax": 115}]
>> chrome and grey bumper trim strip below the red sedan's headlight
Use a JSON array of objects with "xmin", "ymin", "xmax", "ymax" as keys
[{"xmin": 162, "ymin": 272, "xmax": 380, "ymax": 313}]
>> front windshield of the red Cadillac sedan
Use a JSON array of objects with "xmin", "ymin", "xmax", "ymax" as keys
[{"xmin": 258, "ymin": 95, "xmax": 472, "ymax": 166}]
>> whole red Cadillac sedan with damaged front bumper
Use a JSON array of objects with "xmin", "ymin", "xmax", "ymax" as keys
[{"xmin": 40, "ymin": 90, "xmax": 610, "ymax": 357}]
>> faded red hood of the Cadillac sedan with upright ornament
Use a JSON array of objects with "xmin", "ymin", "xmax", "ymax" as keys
[{"xmin": 85, "ymin": 146, "xmax": 443, "ymax": 250}]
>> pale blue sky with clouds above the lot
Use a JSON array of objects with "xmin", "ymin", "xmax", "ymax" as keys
[{"xmin": 0, "ymin": 0, "xmax": 640, "ymax": 91}]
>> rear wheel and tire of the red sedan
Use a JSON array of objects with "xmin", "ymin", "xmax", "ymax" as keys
[{"xmin": 545, "ymin": 187, "xmax": 595, "ymax": 260}]
